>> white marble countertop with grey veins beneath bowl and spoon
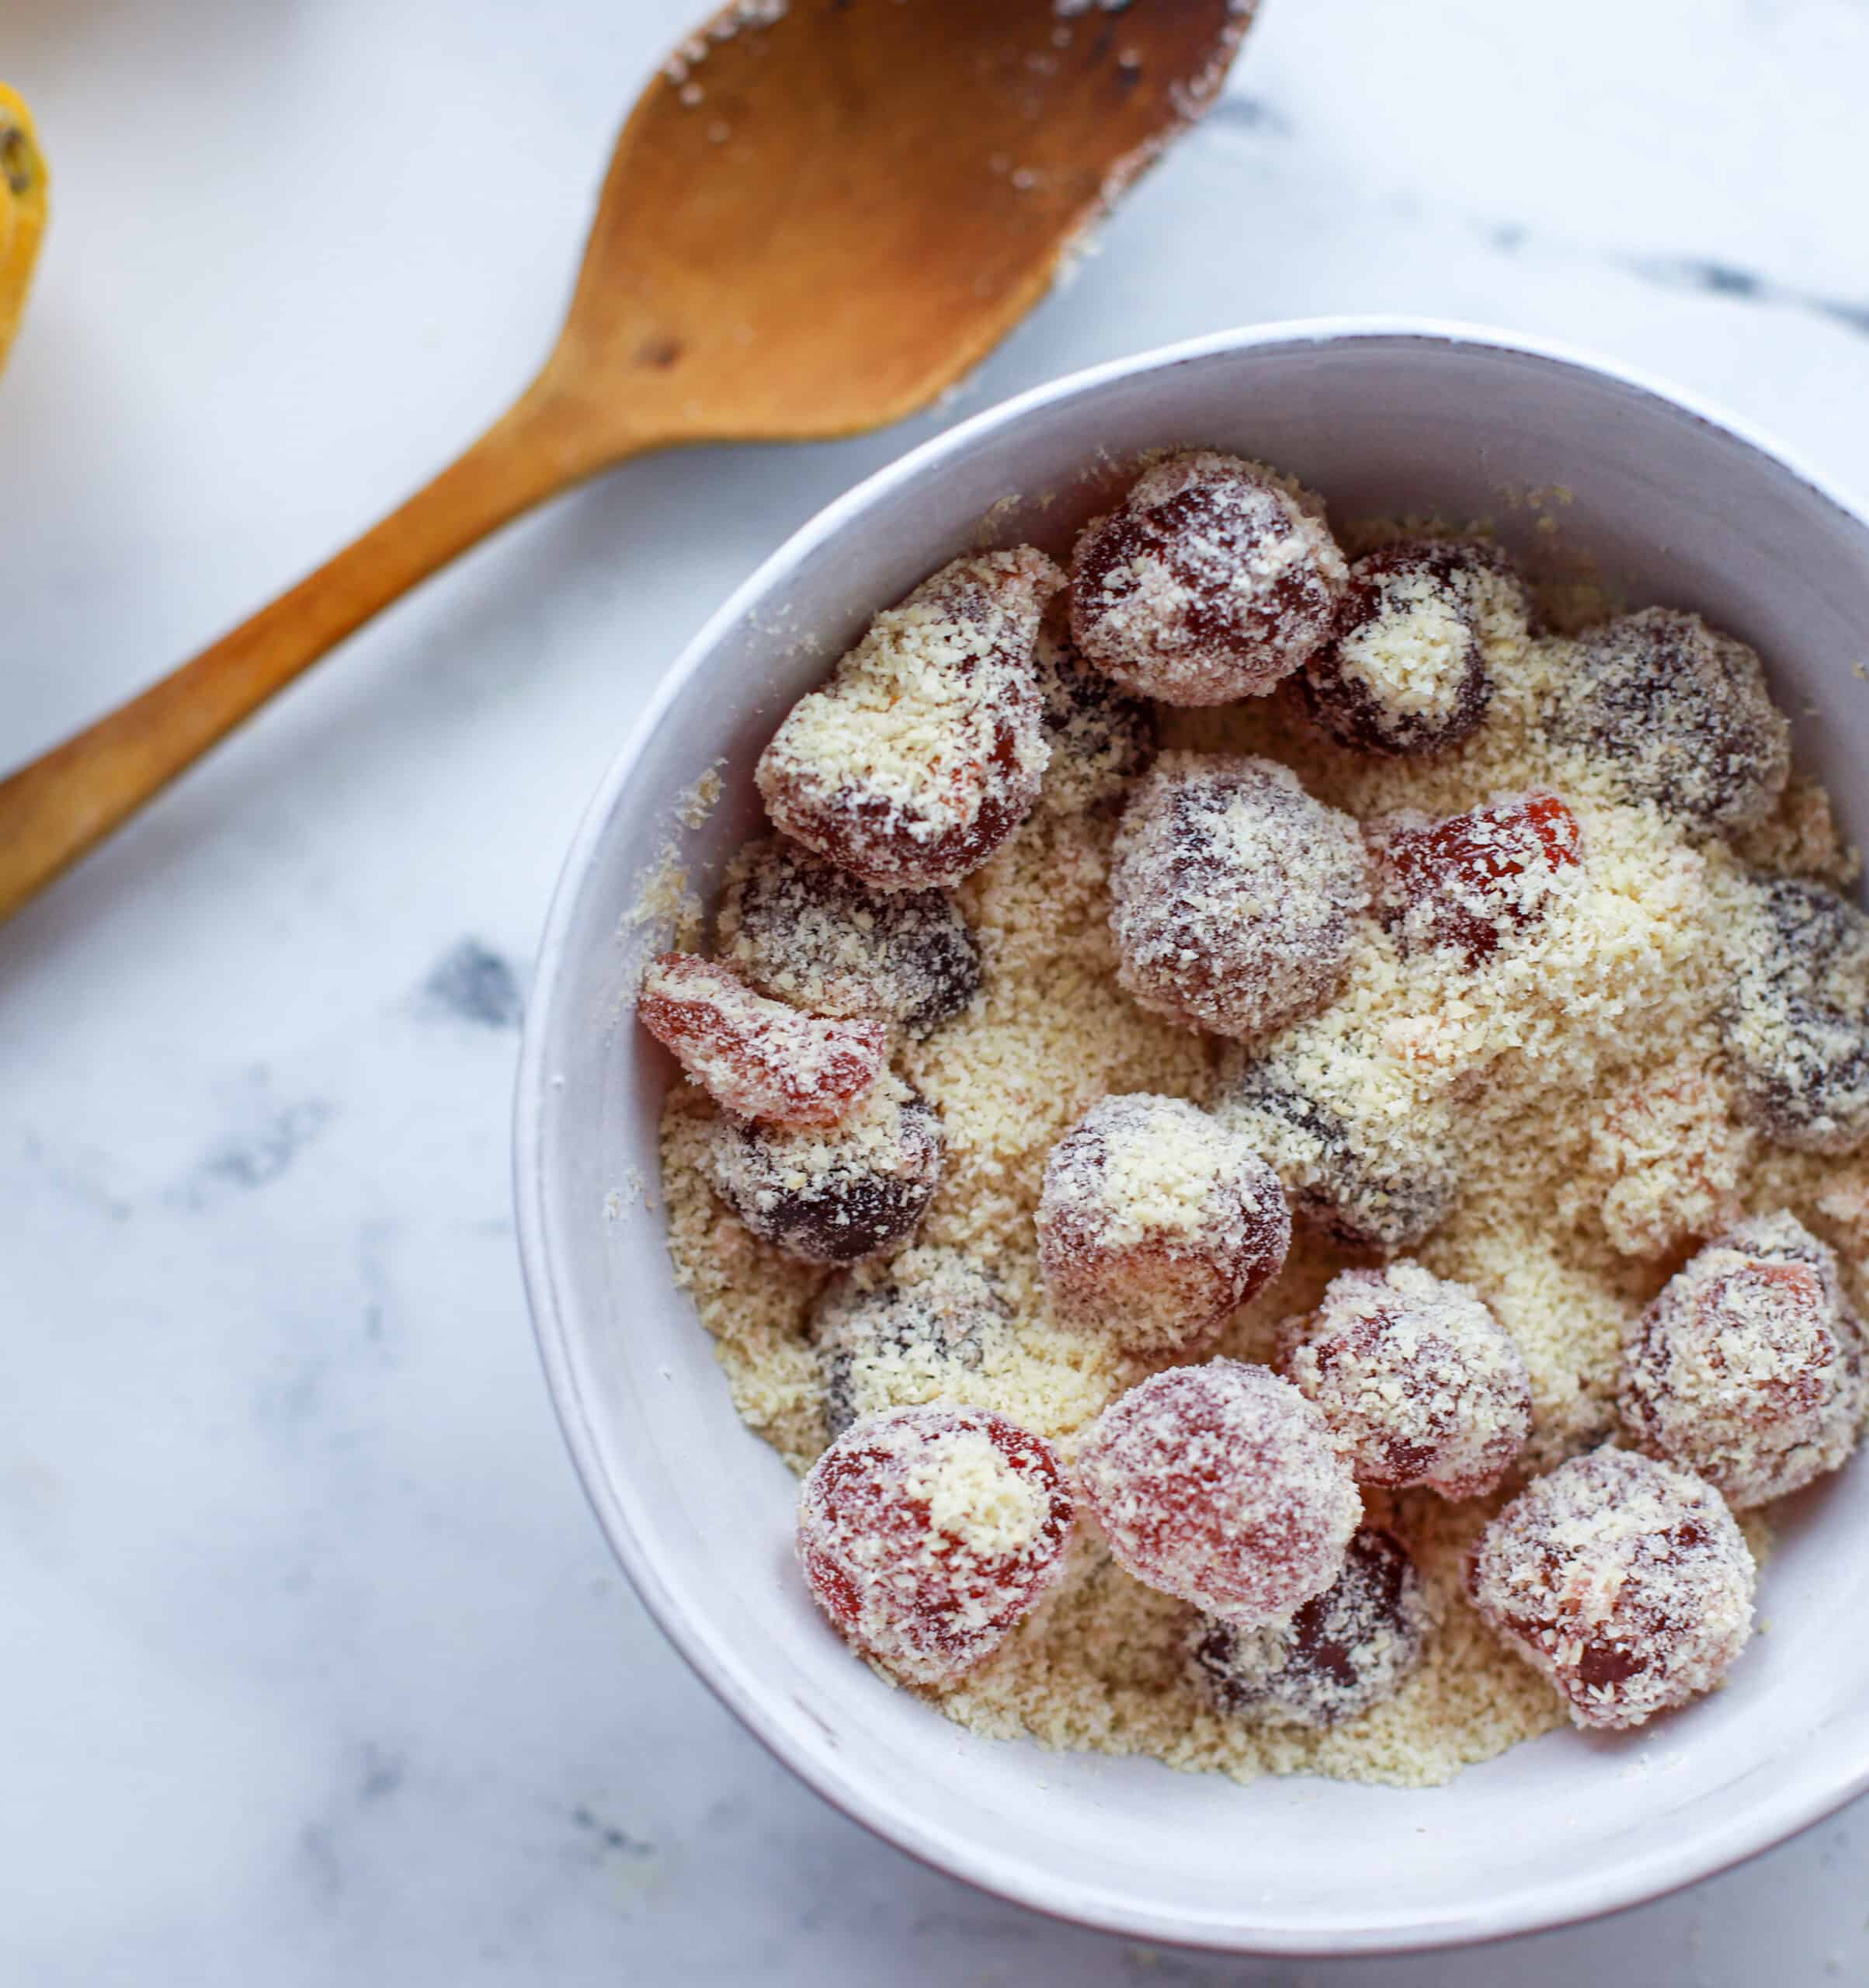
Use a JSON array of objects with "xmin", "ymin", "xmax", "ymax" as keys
[{"xmin": 0, "ymin": 0, "xmax": 1869, "ymax": 1988}]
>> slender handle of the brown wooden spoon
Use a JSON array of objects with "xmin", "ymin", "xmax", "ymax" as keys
[{"xmin": 0, "ymin": 382, "xmax": 627, "ymax": 919}]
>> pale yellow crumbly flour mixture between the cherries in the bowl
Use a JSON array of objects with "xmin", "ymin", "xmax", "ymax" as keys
[{"xmin": 664, "ymin": 540, "xmax": 1869, "ymax": 1785}]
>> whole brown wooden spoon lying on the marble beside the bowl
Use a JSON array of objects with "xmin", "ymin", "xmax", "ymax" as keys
[{"xmin": 0, "ymin": 0, "xmax": 1252, "ymax": 919}]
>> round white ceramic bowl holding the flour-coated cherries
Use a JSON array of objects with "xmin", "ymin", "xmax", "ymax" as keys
[{"xmin": 517, "ymin": 320, "xmax": 1869, "ymax": 1954}]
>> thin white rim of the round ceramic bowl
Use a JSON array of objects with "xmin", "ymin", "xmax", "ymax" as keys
[{"xmin": 513, "ymin": 314, "xmax": 1869, "ymax": 1958}]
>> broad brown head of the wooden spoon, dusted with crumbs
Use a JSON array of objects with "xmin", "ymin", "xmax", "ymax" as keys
[{"xmin": 540, "ymin": 0, "xmax": 1251, "ymax": 467}]
